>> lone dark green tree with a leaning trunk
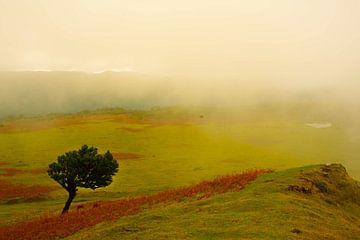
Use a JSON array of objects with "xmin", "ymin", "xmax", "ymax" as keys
[{"xmin": 48, "ymin": 145, "xmax": 119, "ymax": 214}]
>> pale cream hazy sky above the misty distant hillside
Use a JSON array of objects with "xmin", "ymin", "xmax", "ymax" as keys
[{"xmin": 0, "ymin": 0, "xmax": 360, "ymax": 84}]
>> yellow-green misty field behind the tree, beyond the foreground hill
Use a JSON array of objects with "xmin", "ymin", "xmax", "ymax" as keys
[{"xmin": 0, "ymin": 106, "xmax": 360, "ymax": 224}]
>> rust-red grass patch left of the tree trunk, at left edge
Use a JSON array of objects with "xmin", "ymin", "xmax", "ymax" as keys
[{"xmin": 0, "ymin": 180, "xmax": 58, "ymax": 201}]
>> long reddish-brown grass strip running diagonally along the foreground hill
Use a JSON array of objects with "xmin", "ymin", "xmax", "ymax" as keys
[{"xmin": 0, "ymin": 170, "xmax": 270, "ymax": 240}]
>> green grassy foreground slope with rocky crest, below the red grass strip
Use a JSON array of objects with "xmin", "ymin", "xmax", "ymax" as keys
[{"xmin": 67, "ymin": 165, "xmax": 360, "ymax": 240}]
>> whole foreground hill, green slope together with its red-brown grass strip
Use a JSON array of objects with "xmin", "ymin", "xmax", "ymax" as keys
[{"xmin": 0, "ymin": 164, "xmax": 360, "ymax": 240}]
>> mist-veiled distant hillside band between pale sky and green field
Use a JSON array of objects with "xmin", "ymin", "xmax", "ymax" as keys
[{"xmin": 0, "ymin": 71, "xmax": 358, "ymax": 118}]
